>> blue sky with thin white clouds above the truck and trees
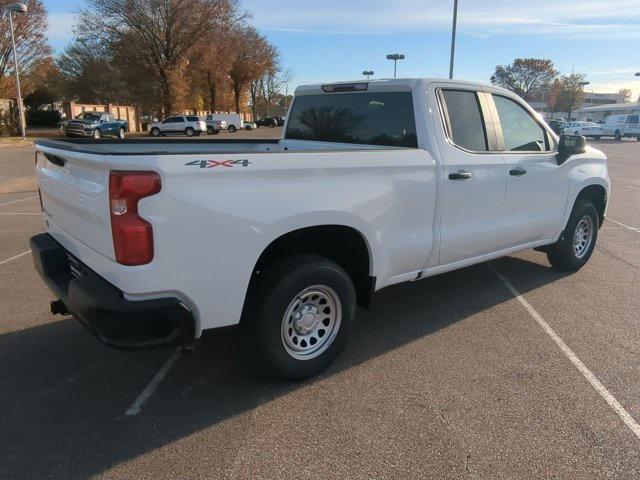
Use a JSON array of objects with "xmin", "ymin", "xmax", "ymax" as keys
[{"xmin": 44, "ymin": 0, "xmax": 640, "ymax": 98}]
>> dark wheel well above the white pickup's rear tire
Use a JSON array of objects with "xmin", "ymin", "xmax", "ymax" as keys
[{"xmin": 249, "ymin": 225, "xmax": 375, "ymax": 307}]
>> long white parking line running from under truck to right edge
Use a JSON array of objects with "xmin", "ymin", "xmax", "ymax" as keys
[{"xmin": 490, "ymin": 264, "xmax": 640, "ymax": 439}]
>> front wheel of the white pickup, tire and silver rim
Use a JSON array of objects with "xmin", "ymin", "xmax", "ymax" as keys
[{"xmin": 547, "ymin": 199, "xmax": 600, "ymax": 272}]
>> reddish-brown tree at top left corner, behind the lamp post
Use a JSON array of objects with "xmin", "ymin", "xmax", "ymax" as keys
[{"xmin": 0, "ymin": 0, "xmax": 51, "ymax": 97}]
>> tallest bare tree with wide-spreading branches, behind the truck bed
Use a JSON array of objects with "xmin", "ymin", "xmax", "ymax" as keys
[{"xmin": 79, "ymin": 0, "xmax": 235, "ymax": 113}]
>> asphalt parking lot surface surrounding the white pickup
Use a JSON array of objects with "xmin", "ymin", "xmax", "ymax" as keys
[{"xmin": 0, "ymin": 136, "xmax": 640, "ymax": 479}]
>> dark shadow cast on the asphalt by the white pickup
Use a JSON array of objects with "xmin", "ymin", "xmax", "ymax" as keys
[{"xmin": 0, "ymin": 253, "xmax": 564, "ymax": 479}]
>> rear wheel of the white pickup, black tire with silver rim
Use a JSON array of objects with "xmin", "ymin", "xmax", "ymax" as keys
[{"xmin": 242, "ymin": 255, "xmax": 357, "ymax": 380}]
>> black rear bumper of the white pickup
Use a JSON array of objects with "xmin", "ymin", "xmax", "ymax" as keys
[{"xmin": 30, "ymin": 233, "xmax": 194, "ymax": 350}]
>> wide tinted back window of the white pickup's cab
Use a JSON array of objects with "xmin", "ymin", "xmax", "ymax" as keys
[{"xmin": 285, "ymin": 92, "xmax": 418, "ymax": 148}]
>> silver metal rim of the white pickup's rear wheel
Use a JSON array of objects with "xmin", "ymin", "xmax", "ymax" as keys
[{"xmin": 281, "ymin": 285, "xmax": 342, "ymax": 360}]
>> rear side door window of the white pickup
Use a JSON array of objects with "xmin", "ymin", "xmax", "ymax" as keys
[{"xmin": 442, "ymin": 90, "xmax": 487, "ymax": 152}]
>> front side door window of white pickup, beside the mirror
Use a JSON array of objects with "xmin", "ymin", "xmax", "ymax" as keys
[{"xmin": 493, "ymin": 95, "xmax": 548, "ymax": 152}]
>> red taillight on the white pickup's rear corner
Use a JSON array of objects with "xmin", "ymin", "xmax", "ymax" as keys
[{"xmin": 109, "ymin": 172, "xmax": 162, "ymax": 266}]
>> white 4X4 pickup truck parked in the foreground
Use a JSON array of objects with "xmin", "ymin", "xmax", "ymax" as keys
[{"xmin": 31, "ymin": 79, "xmax": 610, "ymax": 379}]
